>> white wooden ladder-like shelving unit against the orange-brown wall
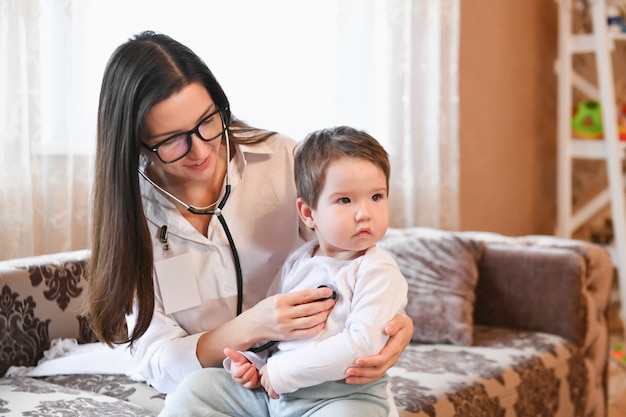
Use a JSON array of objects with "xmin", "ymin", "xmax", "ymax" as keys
[{"xmin": 555, "ymin": 0, "xmax": 626, "ymax": 332}]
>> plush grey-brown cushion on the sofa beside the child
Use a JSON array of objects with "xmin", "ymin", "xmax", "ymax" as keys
[{"xmin": 379, "ymin": 228, "xmax": 484, "ymax": 346}]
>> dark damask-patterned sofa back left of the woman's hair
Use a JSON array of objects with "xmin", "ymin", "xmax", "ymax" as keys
[{"xmin": 0, "ymin": 250, "xmax": 94, "ymax": 376}]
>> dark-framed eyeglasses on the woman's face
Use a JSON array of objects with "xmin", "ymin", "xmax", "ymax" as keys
[{"xmin": 141, "ymin": 109, "xmax": 226, "ymax": 164}]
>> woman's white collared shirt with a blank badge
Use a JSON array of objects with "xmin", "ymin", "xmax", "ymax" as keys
[{"xmin": 127, "ymin": 135, "xmax": 303, "ymax": 393}]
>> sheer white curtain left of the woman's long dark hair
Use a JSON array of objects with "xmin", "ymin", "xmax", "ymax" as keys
[{"xmin": 0, "ymin": 0, "xmax": 93, "ymax": 259}]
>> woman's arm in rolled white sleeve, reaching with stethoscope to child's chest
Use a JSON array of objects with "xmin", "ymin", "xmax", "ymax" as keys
[{"xmin": 126, "ymin": 288, "xmax": 334, "ymax": 394}]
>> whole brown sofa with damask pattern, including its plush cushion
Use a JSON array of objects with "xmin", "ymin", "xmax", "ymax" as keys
[{"xmin": 0, "ymin": 227, "xmax": 614, "ymax": 417}]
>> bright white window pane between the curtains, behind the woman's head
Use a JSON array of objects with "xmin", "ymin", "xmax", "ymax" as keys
[{"xmin": 85, "ymin": 0, "xmax": 339, "ymax": 140}]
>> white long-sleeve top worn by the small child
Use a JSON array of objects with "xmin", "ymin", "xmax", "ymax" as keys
[{"xmin": 260, "ymin": 241, "xmax": 408, "ymax": 394}]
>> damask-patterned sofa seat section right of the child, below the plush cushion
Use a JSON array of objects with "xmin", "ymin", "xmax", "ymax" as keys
[{"xmin": 388, "ymin": 325, "xmax": 590, "ymax": 417}]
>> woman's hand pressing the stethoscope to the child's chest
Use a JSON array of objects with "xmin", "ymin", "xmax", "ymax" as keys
[{"xmin": 242, "ymin": 288, "xmax": 335, "ymax": 340}]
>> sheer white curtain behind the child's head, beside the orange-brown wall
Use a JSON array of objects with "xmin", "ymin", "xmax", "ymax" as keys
[{"xmin": 338, "ymin": 0, "xmax": 460, "ymax": 230}]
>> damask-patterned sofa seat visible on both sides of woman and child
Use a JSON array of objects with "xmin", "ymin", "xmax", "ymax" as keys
[{"xmin": 0, "ymin": 326, "xmax": 588, "ymax": 417}]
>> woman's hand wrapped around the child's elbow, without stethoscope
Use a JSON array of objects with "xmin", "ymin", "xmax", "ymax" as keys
[{"xmin": 346, "ymin": 314, "xmax": 413, "ymax": 384}]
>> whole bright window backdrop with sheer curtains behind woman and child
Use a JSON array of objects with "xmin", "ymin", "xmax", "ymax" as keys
[{"xmin": 0, "ymin": 0, "xmax": 460, "ymax": 259}]
